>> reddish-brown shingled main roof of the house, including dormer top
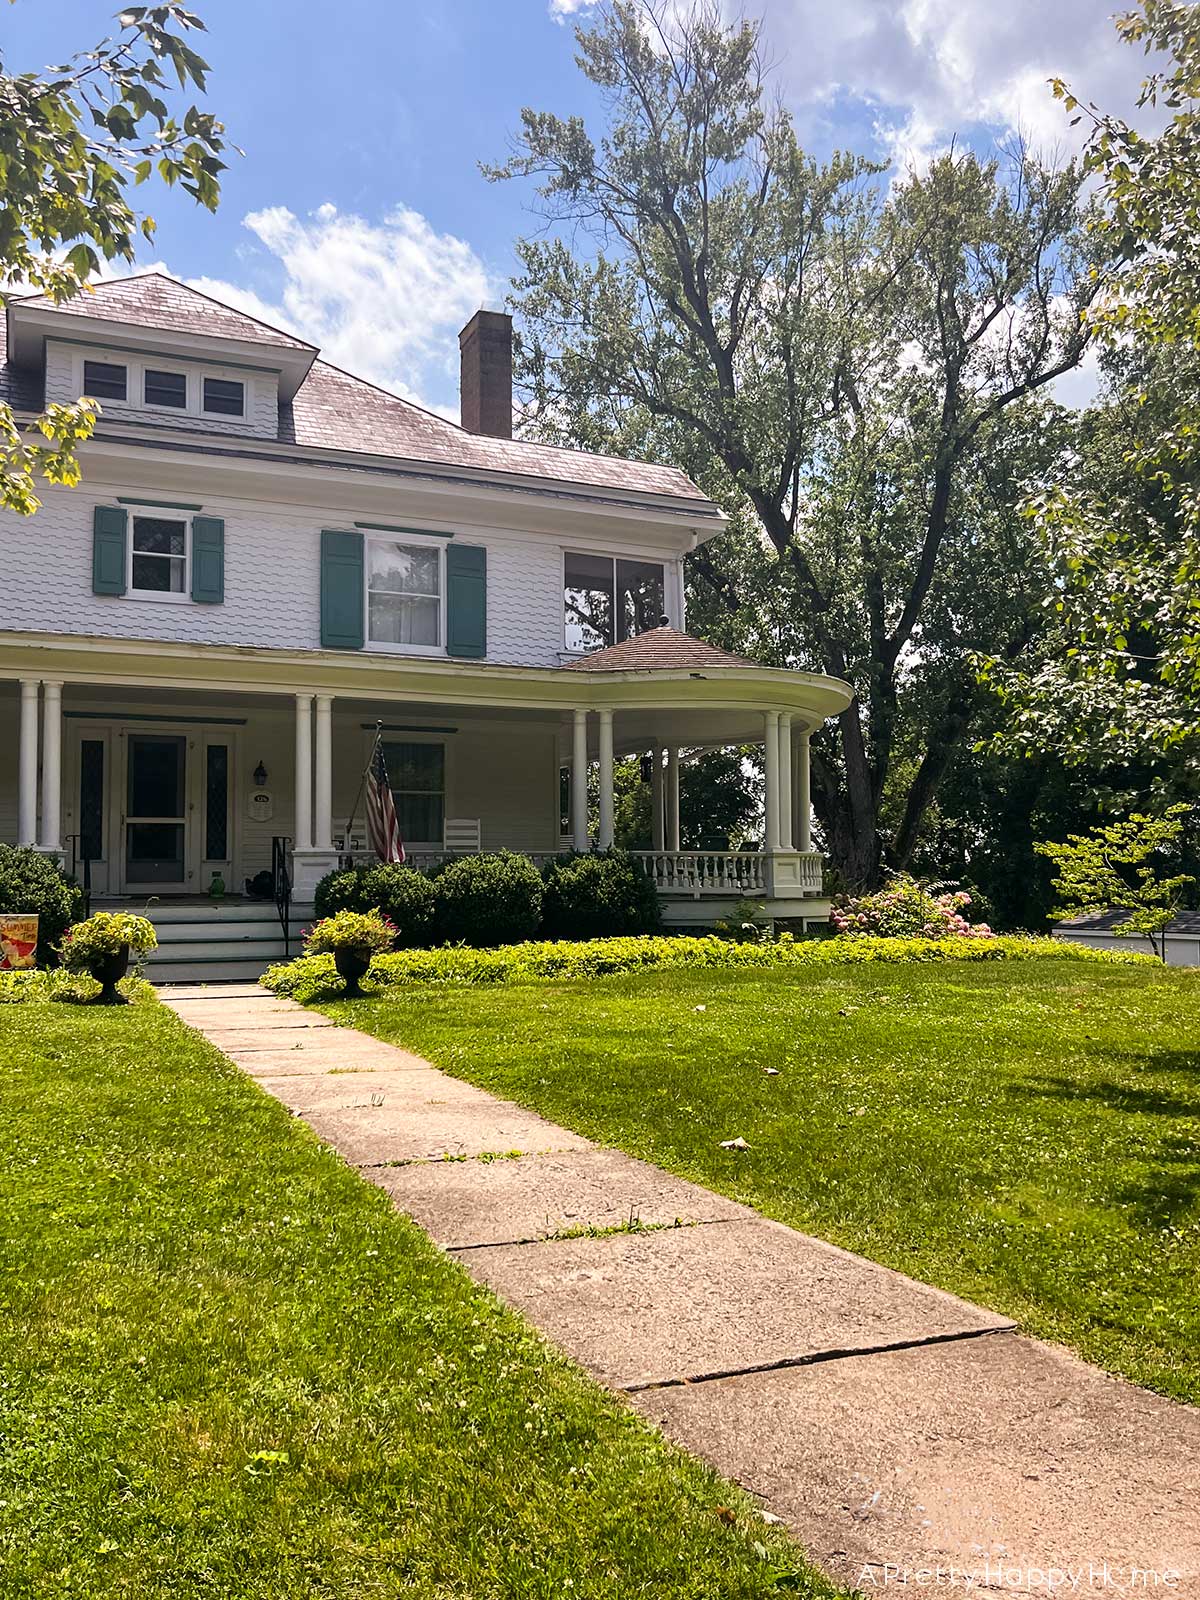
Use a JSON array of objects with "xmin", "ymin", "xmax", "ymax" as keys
[{"xmin": 0, "ymin": 272, "xmax": 718, "ymax": 502}]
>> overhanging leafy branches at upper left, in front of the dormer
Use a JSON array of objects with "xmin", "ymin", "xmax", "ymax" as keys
[{"xmin": 0, "ymin": 0, "xmax": 224, "ymax": 514}]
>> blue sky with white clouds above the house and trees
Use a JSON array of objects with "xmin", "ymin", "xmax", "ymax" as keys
[{"xmin": 0, "ymin": 0, "xmax": 1142, "ymax": 414}]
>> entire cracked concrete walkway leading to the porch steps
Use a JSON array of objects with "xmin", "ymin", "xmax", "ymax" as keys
[{"xmin": 162, "ymin": 984, "xmax": 1200, "ymax": 1597}]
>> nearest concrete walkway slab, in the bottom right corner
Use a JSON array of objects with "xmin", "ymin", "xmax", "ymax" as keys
[{"xmin": 630, "ymin": 1333, "xmax": 1200, "ymax": 1595}]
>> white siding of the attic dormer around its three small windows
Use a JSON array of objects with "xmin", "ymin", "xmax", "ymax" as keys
[{"xmin": 46, "ymin": 339, "xmax": 278, "ymax": 438}]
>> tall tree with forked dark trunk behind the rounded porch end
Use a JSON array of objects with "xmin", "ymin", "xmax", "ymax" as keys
[{"xmin": 493, "ymin": 0, "xmax": 1098, "ymax": 885}]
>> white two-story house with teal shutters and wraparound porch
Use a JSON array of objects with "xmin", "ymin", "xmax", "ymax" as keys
[{"xmin": 0, "ymin": 274, "xmax": 850, "ymax": 972}]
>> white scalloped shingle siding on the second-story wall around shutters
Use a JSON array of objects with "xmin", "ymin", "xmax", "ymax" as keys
[{"xmin": 0, "ymin": 485, "xmax": 579, "ymax": 666}]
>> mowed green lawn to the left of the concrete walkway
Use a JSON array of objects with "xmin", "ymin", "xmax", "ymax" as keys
[{"xmin": 0, "ymin": 1000, "xmax": 829, "ymax": 1600}]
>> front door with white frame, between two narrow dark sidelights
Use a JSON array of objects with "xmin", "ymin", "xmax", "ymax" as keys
[{"xmin": 125, "ymin": 733, "xmax": 187, "ymax": 893}]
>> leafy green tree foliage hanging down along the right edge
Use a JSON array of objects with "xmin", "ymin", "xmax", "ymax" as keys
[{"xmin": 989, "ymin": 0, "xmax": 1200, "ymax": 762}]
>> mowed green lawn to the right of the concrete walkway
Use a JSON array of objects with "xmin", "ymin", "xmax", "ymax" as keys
[{"xmin": 325, "ymin": 958, "xmax": 1200, "ymax": 1402}]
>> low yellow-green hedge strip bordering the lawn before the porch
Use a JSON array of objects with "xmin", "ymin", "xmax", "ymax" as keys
[{"xmin": 261, "ymin": 934, "xmax": 1158, "ymax": 1000}]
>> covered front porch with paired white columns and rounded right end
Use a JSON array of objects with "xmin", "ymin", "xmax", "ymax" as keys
[{"xmin": 0, "ymin": 624, "xmax": 857, "ymax": 925}]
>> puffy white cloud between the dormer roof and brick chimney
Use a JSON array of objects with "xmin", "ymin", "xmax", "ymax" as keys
[{"xmin": 180, "ymin": 205, "xmax": 502, "ymax": 419}]
